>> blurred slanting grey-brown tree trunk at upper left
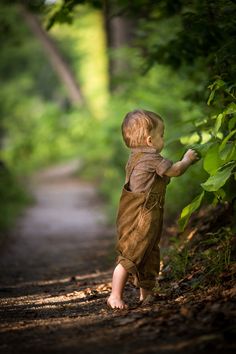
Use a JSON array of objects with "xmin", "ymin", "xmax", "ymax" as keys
[{"xmin": 20, "ymin": 5, "xmax": 84, "ymax": 105}]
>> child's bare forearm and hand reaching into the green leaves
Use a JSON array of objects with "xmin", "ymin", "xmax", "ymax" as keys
[{"xmin": 164, "ymin": 149, "xmax": 198, "ymax": 177}]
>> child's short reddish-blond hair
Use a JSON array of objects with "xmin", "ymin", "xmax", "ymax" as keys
[{"xmin": 121, "ymin": 109, "xmax": 163, "ymax": 148}]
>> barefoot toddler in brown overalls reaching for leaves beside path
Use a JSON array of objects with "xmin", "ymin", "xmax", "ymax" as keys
[{"xmin": 107, "ymin": 109, "xmax": 198, "ymax": 309}]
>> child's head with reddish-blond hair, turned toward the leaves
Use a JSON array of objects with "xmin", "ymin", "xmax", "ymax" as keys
[{"xmin": 121, "ymin": 109, "xmax": 164, "ymax": 151}]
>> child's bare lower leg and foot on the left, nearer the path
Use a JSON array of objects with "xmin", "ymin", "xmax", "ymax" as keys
[{"xmin": 107, "ymin": 263, "xmax": 128, "ymax": 309}]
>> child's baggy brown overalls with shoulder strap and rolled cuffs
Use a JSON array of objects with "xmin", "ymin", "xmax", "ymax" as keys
[{"xmin": 117, "ymin": 152, "xmax": 170, "ymax": 290}]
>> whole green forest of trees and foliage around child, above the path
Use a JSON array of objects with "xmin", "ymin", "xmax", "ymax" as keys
[{"xmin": 0, "ymin": 0, "xmax": 236, "ymax": 236}]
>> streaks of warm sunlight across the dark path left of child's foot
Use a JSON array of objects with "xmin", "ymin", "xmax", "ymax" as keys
[{"xmin": 1, "ymin": 272, "xmax": 111, "ymax": 333}]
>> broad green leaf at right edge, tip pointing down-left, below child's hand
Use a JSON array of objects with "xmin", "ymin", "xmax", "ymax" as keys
[{"xmin": 201, "ymin": 161, "xmax": 236, "ymax": 192}]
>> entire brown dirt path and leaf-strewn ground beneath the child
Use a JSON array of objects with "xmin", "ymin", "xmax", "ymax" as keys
[{"xmin": 0, "ymin": 161, "xmax": 236, "ymax": 354}]
